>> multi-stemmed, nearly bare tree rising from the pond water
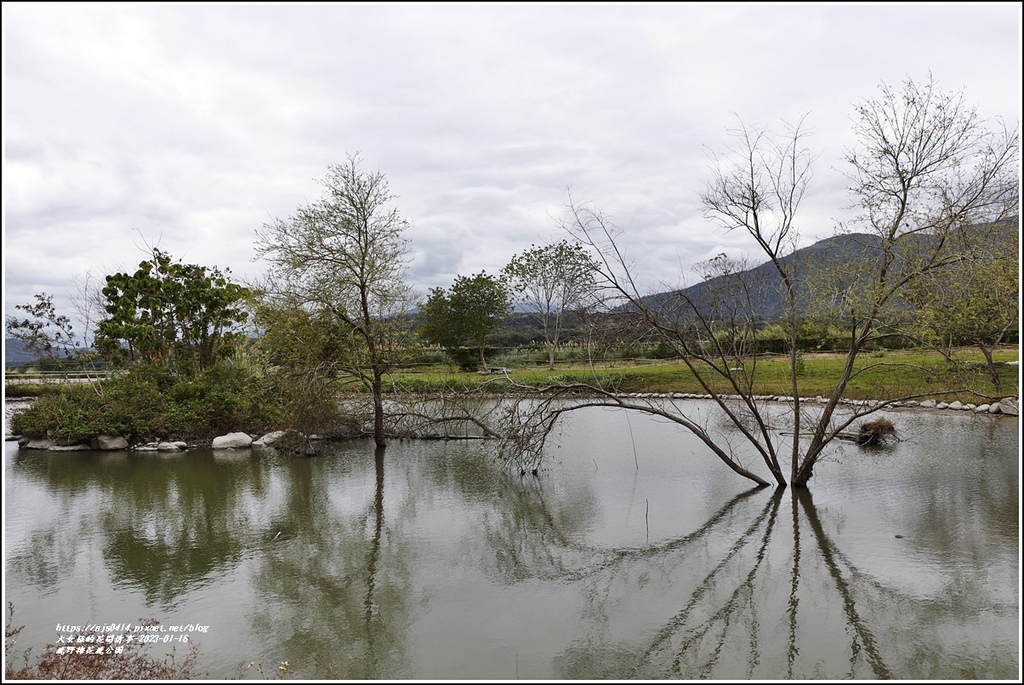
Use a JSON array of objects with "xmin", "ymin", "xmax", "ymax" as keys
[{"xmin": 506, "ymin": 79, "xmax": 1019, "ymax": 486}]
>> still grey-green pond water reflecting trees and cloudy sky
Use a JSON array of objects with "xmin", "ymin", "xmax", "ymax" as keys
[{"xmin": 4, "ymin": 401, "xmax": 1020, "ymax": 680}]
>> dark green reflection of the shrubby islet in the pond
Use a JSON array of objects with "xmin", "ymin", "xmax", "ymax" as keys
[{"xmin": 7, "ymin": 451, "xmax": 276, "ymax": 609}]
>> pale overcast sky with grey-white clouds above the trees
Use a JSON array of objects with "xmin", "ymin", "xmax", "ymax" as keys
[{"xmin": 2, "ymin": 2, "xmax": 1021, "ymax": 341}]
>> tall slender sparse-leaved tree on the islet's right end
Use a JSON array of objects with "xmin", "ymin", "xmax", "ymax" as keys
[{"xmin": 256, "ymin": 155, "xmax": 413, "ymax": 446}]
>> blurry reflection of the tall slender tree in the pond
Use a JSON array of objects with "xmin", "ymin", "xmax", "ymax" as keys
[{"xmin": 251, "ymin": 448, "xmax": 414, "ymax": 680}]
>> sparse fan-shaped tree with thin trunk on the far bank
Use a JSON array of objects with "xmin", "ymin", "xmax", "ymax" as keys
[{"xmin": 503, "ymin": 240, "xmax": 597, "ymax": 369}]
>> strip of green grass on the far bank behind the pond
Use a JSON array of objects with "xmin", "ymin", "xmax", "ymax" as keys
[{"xmin": 382, "ymin": 347, "xmax": 1020, "ymax": 402}]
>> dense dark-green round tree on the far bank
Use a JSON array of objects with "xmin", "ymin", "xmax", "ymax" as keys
[{"xmin": 418, "ymin": 271, "xmax": 512, "ymax": 371}]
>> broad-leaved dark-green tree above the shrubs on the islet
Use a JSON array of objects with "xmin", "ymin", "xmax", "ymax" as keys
[{"xmin": 96, "ymin": 249, "xmax": 249, "ymax": 375}]
